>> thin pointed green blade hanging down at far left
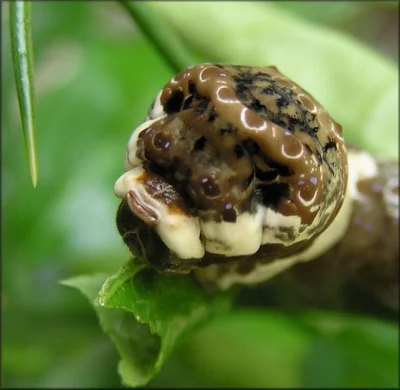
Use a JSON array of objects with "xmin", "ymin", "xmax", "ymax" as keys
[{"xmin": 9, "ymin": 1, "xmax": 38, "ymax": 187}]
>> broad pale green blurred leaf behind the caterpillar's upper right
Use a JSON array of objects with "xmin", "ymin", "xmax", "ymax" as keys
[{"xmin": 149, "ymin": 2, "xmax": 399, "ymax": 158}]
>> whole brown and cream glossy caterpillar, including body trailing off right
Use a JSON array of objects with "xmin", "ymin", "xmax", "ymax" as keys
[{"xmin": 114, "ymin": 64, "xmax": 399, "ymax": 307}]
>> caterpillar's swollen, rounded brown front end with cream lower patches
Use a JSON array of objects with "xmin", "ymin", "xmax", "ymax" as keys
[{"xmin": 115, "ymin": 64, "xmax": 347, "ymax": 280}]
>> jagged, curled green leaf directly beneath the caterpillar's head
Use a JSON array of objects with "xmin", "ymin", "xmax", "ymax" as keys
[{"xmin": 63, "ymin": 261, "xmax": 232, "ymax": 387}]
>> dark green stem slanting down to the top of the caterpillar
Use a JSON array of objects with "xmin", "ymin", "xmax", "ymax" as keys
[{"xmin": 120, "ymin": 1, "xmax": 195, "ymax": 73}]
